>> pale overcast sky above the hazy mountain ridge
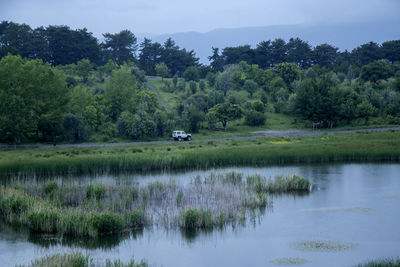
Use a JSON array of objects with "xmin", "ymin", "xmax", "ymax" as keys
[{"xmin": 0, "ymin": 0, "xmax": 400, "ymax": 37}]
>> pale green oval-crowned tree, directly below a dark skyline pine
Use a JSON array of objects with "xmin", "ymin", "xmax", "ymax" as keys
[{"xmin": 104, "ymin": 65, "xmax": 137, "ymax": 121}]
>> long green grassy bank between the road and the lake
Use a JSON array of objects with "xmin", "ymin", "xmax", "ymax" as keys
[{"xmin": 0, "ymin": 131, "xmax": 400, "ymax": 176}]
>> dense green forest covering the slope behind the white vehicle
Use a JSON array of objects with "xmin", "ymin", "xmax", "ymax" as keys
[{"xmin": 0, "ymin": 21, "xmax": 400, "ymax": 144}]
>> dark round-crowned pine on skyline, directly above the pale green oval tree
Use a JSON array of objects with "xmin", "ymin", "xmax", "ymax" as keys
[{"xmin": 102, "ymin": 30, "xmax": 137, "ymax": 65}]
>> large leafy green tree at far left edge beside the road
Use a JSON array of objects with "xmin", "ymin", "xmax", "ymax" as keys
[{"xmin": 0, "ymin": 55, "xmax": 69, "ymax": 143}]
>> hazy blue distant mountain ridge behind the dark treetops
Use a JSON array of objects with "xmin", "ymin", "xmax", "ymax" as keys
[{"xmin": 144, "ymin": 18, "xmax": 400, "ymax": 64}]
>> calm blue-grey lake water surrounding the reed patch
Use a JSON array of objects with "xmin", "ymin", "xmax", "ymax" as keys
[{"xmin": 0, "ymin": 164, "xmax": 400, "ymax": 266}]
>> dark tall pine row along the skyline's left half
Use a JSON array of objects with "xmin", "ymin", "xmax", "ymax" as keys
[{"xmin": 0, "ymin": 21, "xmax": 199, "ymax": 75}]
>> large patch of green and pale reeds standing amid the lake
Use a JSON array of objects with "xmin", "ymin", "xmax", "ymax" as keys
[{"xmin": 0, "ymin": 172, "xmax": 312, "ymax": 238}]
